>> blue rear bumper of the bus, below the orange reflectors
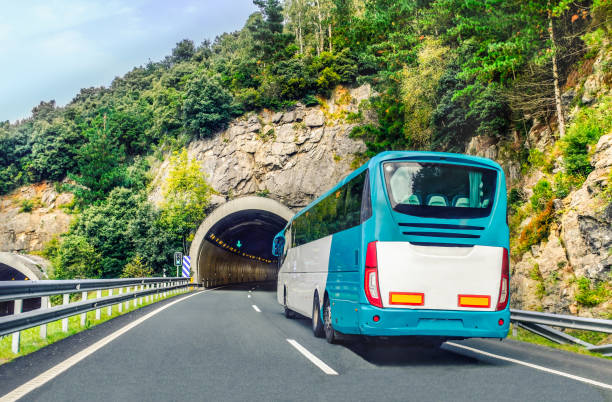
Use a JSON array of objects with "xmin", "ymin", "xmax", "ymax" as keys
[{"xmin": 359, "ymin": 305, "xmax": 510, "ymax": 338}]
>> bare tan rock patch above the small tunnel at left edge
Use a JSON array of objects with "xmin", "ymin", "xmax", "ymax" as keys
[{"xmin": 0, "ymin": 183, "xmax": 73, "ymax": 252}]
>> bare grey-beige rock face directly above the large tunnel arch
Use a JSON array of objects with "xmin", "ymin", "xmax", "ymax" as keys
[{"xmin": 150, "ymin": 86, "xmax": 371, "ymax": 209}]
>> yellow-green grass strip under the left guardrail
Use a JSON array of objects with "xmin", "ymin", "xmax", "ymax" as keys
[{"xmin": 0, "ymin": 289, "xmax": 192, "ymax": 365}]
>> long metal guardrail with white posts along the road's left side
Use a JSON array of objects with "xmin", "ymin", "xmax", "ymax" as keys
[{"xmin": 0, "ymin": 278, "xmax": 194, "ymax": 354}]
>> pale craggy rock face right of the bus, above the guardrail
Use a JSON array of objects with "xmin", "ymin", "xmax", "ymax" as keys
[{"xmin": 511, "ymin": 133, "xmax": 612, "ymax": 317}]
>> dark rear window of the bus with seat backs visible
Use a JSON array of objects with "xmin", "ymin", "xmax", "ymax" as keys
[{"xmin": 383, "ymin": 162, "xmax": 497, "ymax": 219}]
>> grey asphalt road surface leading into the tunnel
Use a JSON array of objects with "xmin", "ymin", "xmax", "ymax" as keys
[{"xmin": 0, "ymin": 285, "xmax": 612, "ymax": 402}]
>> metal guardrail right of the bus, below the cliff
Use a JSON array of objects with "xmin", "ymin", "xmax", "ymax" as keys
[{"xmin": 510, "ymin": 309, "xmax": 612, "ymax": 356}]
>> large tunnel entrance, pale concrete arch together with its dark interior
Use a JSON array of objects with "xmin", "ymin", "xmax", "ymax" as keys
[{"xmin": 189, "ymin": 196, "xmax": 294, "ymax": 286}]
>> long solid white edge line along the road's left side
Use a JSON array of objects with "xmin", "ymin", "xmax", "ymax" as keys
[{"xmin": 0, "ymin": 286, "xmax": 223, "ymax": 402}]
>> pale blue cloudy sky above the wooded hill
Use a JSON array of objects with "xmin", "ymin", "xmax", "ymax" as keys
[{"xmin": 0, "ymin": 0, "xmax": 257, "ymax": 122}]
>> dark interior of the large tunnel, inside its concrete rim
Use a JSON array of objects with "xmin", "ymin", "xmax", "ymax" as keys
[{"xmin": 197, "ymin": 209, "xmax": 287, "ymax": 286}]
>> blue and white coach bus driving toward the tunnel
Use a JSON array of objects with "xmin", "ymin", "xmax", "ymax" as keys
[{"xmin": 273, "ymin": 151, "xmax": 510, "ymax": 344}]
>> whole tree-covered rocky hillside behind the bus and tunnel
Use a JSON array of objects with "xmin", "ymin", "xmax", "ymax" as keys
[{"xmin": 0, "ymin": 0, "xmax": 612, "ymax": 316}]
